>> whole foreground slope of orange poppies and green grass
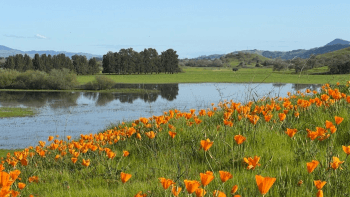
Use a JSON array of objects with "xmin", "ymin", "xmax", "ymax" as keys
[{"xmin": 0, "ymin": 83, "xmax": 350, "ymax": 197}]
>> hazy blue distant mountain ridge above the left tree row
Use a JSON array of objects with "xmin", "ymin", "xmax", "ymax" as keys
[{"xmin": 0, "ymin": 45, "xmax": 102, "ymax": 59}]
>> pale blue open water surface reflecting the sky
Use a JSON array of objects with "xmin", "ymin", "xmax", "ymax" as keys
[{"xmin": 0, "ymin": 83, "xmax": 320, "ymax": 149}]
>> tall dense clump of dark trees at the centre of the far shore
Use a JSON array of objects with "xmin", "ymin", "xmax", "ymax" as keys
[{"xmin": 102, "ymin": 48, "xmax": 180, "ymax": 75}]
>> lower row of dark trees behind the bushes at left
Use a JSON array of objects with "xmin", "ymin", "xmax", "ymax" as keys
[{"xmin": 3, "ymin": 53, "xmax": 100, "ymax": 75}]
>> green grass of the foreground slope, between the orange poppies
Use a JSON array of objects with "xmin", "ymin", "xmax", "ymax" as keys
[{"xmin": 0, "ymin": 84, "xmax": 350, "ymax": 197}]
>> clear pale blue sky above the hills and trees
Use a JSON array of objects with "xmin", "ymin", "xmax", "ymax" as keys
[{"xmin": 0, "ymin": 0, "xmax": 350, "ymax": 58}]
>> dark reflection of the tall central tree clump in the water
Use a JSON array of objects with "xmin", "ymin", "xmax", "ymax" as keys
[{"xmin": 96, "ymin": 84, "xmax": 179, "ymax": 106}]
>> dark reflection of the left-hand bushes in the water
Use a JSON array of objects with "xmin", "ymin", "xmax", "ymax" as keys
[{"xmin": 0, "ymin": 92, "xmax": 80, "ymax": 108}]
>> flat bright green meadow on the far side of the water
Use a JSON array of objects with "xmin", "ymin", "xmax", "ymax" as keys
[{"xmin": 78, "ymin": 68, "xmax": 350, "ymax": 84}]
